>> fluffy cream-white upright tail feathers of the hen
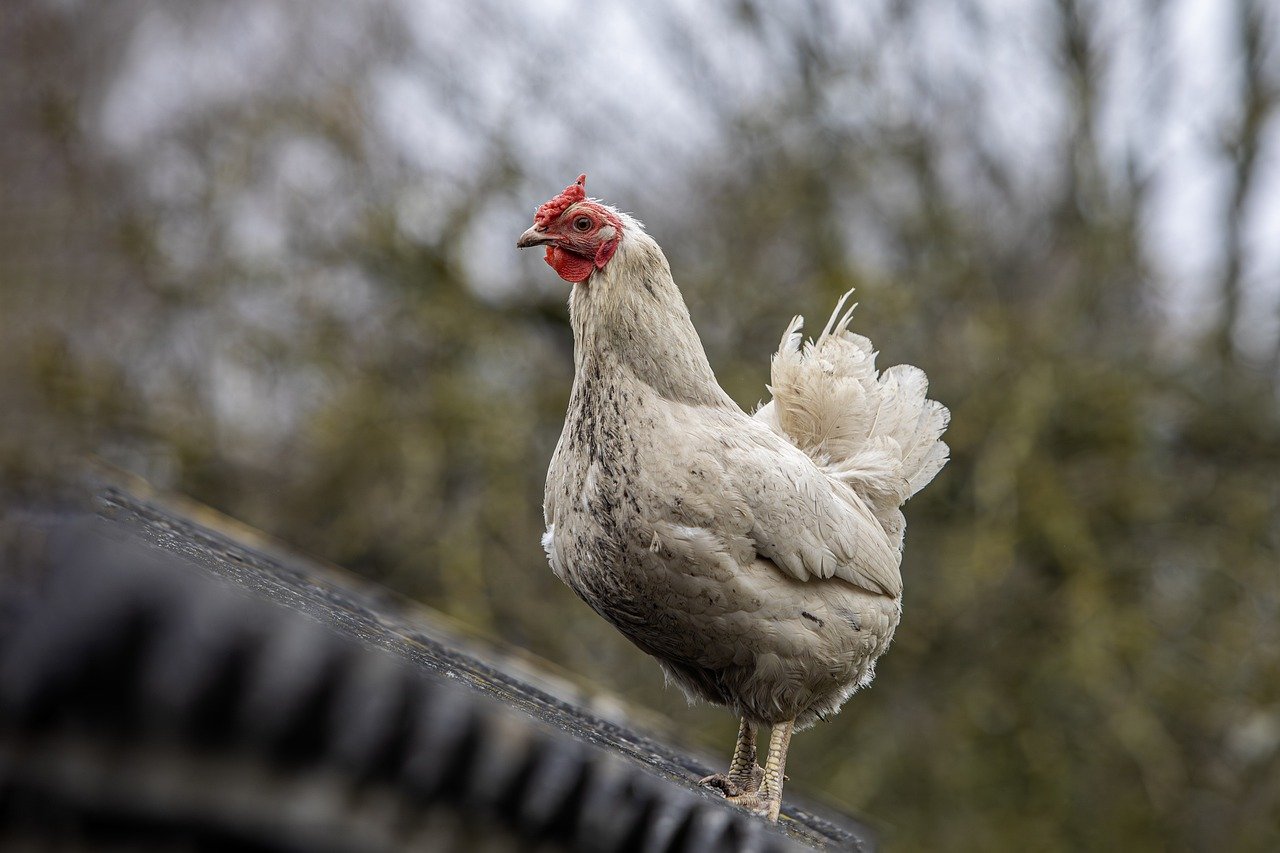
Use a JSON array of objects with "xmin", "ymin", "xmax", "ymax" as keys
[{"xmin": 755, "ymin": 291, "xmax": 951, "ymax": 535}]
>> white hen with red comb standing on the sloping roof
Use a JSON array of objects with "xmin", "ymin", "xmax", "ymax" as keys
[{"xmin": 517, "ymin": 175, "xmax": 948, "ymax": 820}]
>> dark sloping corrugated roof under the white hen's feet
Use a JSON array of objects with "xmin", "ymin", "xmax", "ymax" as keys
[{"xmin": 0, "ymin": 488, "xmax": 870, "ymax": 850}]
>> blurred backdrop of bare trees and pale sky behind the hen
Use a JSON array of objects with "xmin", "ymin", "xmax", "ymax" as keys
[{"xmin": 0, "ymin": 0, "xmax": 1280, "ymax": 850}]
